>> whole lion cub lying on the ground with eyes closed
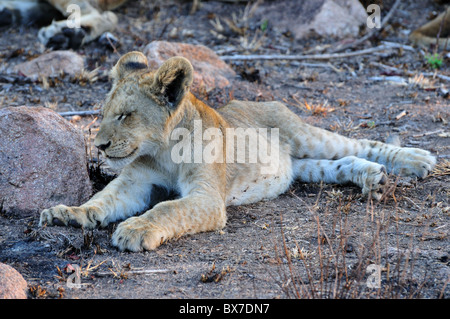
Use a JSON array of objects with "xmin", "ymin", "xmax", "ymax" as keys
[{"xmin": 39, "ymin": 52, "xmax": 436, "ymax": 251}]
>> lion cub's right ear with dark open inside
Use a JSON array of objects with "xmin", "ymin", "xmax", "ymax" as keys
[{"xmin": 152, "ymin": 57, "xmax": 194, "ymax": 108}]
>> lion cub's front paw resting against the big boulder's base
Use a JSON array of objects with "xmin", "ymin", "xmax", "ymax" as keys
[{"xmin": 39, "ymin": 205, "xmax": 103, "ymax": 229}]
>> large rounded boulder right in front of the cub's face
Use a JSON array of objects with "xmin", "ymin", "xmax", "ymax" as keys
[{"xmin": 0, "ymin": 106, "xmax": 91, "ymax": 216}]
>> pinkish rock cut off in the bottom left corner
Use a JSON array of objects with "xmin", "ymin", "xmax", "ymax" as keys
[{"xmin": 0, "ymin": 263, "xmax": 27, "ymax": 299}]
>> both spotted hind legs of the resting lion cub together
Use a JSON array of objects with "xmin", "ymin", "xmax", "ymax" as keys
[{"xmin": 284, "ymin": 106, "xmax": 436, "ymax": 199}]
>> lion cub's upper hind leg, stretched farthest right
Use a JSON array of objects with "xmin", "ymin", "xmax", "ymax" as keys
[{"xmin": 269, "ymin": 103, "xmax": 436, "ymax": 178}]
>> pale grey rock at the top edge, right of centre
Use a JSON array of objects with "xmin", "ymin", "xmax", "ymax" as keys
[{"xmin": 255, "ymin": 0, "xmax": 367, "ymax": 39}]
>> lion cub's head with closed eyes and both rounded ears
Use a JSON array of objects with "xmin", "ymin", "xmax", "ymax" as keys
[{"xmin": 95, "ymin": 52, "xmax": 193, "ymax": 167}]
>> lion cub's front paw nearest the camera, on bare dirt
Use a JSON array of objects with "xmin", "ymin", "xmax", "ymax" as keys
[{"xmin": 112, "ymin": 217, "xmax": 165, "ymax": 251}]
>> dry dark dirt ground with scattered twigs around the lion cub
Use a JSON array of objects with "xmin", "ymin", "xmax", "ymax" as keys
[{"xmin": 0, "ymin": 0, "xmax": 450, "ymax": 298}]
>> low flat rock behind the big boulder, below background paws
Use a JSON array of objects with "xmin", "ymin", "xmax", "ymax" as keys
[{"xmin": 12, "ymin": 51, "xmax": 84, "ymax": 80}]
